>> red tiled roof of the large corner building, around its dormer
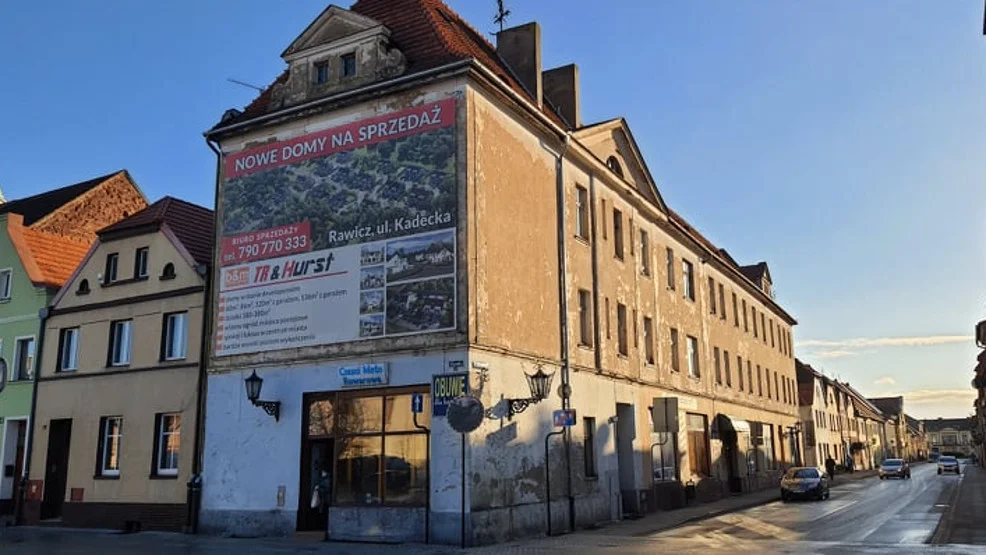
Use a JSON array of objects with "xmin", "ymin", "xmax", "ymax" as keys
[{"xmin": 217, "ymin": 0, "xmax": 568, "ymax": 127}]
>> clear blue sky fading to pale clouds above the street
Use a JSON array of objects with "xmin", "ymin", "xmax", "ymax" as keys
[{"xmin": 0, "ymin": 0, "xmax": 986, "ymax": 418}]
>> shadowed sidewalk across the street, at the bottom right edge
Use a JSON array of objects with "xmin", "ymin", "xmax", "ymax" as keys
[{"xmin": 931, "ymin": 465, "xmax": 986, "ymax": 545}]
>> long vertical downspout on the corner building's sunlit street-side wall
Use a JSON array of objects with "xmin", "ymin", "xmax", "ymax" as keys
[{"xmin": 548, "ymin": 133, "xmax": 575, "ymax": 532}]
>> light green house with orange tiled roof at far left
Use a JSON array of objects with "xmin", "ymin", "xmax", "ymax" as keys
[{"xmin": 0, "ymin": 171, "xmax": 147, "ymax": 516}]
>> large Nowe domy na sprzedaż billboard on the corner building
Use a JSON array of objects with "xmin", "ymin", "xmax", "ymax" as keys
[{"xmin": 215, "ymin": 99, "xmax": 456, "ymax": 356}]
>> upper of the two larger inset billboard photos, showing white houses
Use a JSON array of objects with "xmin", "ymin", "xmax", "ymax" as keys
[{"xmin": 387, "ymin": 229, "xmax": 455, "ymax": 283}]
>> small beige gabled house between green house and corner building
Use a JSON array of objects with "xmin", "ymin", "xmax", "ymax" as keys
[{"xmin": 25, "ymin": 197, "xmax": 214, "ymax": 530}]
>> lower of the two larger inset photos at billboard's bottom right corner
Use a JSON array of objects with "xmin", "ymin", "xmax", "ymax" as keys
[{"xmin": 387, "ymin": 277, "xmax": 455, "ymax": 334}]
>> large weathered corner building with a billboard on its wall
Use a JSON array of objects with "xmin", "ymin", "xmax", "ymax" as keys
[{"xmin": 200, "ymin": 0, "xmax": 800, "ymax": 545}]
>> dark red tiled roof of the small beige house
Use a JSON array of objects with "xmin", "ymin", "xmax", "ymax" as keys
[{"xmin": 99, "ymin": 197, "xmax": 215, "ymax": 265}]
